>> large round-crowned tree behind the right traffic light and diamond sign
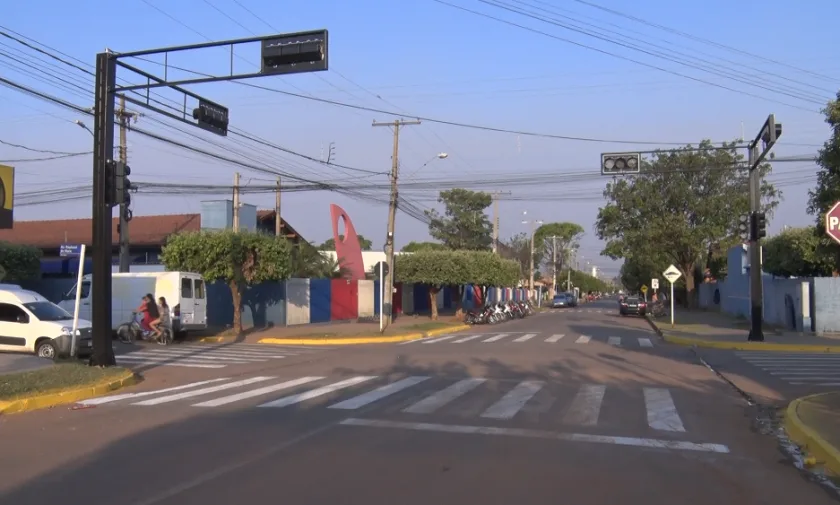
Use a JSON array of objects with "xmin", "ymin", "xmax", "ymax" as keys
[{"xmin": 596, "ymin": 140, "xmax": 780, "ymax": 303}]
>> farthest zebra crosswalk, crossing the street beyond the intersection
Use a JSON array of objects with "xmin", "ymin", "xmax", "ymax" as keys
[{"xmin": 396, "ymin": 332, "xmax": 654, "ymax": 348}]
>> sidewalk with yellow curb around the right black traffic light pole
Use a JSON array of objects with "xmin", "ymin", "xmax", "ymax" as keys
[{"xmin": 648, "ymin": 307, "xmax": 840, "ymax": 353}]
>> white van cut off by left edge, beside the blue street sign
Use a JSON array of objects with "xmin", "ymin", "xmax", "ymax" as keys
[{"xmin": 0, "ymin": 286, "xmax": 93, "ymax": 359}]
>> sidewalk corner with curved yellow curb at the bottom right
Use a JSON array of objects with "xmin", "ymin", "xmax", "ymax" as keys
[{"xmin": 784, "ymin": 391, "xmax": 840, "ymax": 478}]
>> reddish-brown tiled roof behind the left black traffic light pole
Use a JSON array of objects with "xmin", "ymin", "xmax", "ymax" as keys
[{"xmin": 0, "ymin": 214, "xmax": 201, "ymax": 249}]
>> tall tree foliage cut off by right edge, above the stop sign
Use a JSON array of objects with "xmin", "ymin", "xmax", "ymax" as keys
[{"xmin": 808, "ymin": 91, "xmax": 840, "ymax": 275}]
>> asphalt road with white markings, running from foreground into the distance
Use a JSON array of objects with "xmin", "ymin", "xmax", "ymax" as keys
[{"xmin": 0, "ymin": 301, "xmax": 836, "ymax": 505}]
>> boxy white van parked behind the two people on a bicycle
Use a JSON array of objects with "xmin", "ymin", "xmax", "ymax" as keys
[{"xmin": 59, "ymin": 272, "xmax": 207, "ymax": 332}]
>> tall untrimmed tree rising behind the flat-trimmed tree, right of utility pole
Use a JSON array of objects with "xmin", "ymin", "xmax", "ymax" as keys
[{"xmin": 425, "ymin": 188, "xmax": 493, "ymax": 251}]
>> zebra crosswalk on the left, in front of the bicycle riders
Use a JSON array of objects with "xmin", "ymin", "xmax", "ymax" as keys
[{"xmin": 108, "ymin": 344, "xmax": 324, "ymax": 368}]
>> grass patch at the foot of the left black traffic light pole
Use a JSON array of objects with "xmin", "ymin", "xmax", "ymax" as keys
[{"xmin": 0, "ymin": 363, "xmax": 125, "ymax": 401}]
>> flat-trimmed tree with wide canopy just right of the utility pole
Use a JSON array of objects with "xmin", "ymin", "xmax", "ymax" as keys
[{"xmin": 394, "ymin": 251, "xmax": 519, "ymax": 320}]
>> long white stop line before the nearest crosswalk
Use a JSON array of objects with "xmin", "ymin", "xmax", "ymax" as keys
[{"xmin": 339, "ymin": 418, "xmax": 729, "ymax": 454}]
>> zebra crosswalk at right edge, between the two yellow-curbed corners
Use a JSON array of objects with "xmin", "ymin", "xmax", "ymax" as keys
[{"xmin": 736, "ymin": 351, "xmax": 840, "ymax": 387}]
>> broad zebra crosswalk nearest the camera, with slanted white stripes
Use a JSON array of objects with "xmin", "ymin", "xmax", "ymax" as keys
[{"xmin": 79, "ymin": 375, "xmax": 686, "ymax": 432}]
